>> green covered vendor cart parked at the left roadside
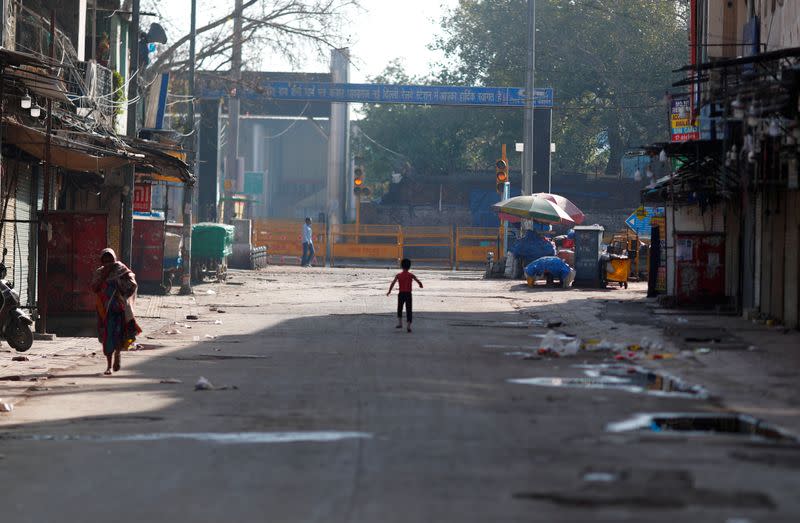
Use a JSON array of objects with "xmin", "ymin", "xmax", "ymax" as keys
[{"xmin": 192, "ymin": 223, "xmax": 234, "ymax": 282}]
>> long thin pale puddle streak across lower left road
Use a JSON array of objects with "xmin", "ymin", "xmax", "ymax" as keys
[{"xmin": 0, "ymin": 431, "xmax": 372, "ymax": 445}]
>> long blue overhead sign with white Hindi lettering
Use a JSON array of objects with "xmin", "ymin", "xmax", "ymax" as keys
[{"xmin": 203, "ymin": 82, "xmax": 553, "ymax": 108}]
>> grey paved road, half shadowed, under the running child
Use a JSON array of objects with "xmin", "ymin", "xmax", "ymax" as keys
[{"xmin": 0, "ymin": 268, "xmax": 800, "ymax": 523}]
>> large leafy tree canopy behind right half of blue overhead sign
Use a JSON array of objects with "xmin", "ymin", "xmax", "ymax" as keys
[{"xmin": 356, "ymin": 0, "xmax": 689, "ymax": 185}]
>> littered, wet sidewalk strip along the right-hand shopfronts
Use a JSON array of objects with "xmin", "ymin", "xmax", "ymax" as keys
[{"xmin": 514, "ymin": 283, "xmax": 800, "ymax": 435}]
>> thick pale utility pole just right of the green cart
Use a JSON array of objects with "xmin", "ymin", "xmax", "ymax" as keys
[{"xmin": 223, "ymin": 0, "xmax": 242, "ymax": 223}]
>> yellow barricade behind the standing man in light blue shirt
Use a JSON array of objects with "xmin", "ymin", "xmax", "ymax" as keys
[{"xmin": 253, "ymin": 219, "xmax": 327, "ymax": 265}]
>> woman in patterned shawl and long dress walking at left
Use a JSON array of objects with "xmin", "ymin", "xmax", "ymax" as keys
[{"xmin": 92, "ymin": 249, "xmax": 142, "ymax": 375}]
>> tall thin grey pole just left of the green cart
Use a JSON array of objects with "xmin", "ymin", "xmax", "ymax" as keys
[{"xmin": 180, "ymin": 0, "xmax": 197, "ymax": 295}]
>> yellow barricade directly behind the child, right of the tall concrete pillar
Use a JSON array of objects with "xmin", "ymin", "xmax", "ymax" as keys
[{"xmin": 331, "ymin": 224, "xmax": 403, "ymax": 266}]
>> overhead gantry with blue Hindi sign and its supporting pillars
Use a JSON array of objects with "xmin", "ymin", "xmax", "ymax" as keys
[{"xmin": 198, "ymin": 50, "xmax": 553, "ymax": 224}]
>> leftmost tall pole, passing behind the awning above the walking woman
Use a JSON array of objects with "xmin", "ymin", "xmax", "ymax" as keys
[{"xmin": 120, "ymin": 0, "xmax": 139, "ymax": 265}]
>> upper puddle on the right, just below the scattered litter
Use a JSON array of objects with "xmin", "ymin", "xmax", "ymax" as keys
[{"xmin": 508, "ymin": 364, "xmax": 708, "ymax": 399}]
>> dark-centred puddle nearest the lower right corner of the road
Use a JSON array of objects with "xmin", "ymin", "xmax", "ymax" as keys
[{"xmin": 606, "ymin": 413, "xmax": 800, "ymax": 444}]
